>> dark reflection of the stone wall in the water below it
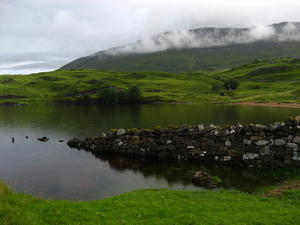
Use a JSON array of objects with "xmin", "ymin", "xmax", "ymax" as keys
[{"xmin": 96, "ymin": 155, "xmax": 274, "ymax": 192}]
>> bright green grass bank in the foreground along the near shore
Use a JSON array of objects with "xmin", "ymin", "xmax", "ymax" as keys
[{"xmin": 0, "ymin": 184, "xmax": 300, "ymax": 225}]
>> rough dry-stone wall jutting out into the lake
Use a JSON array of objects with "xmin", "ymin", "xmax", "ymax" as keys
[{"xmin": 68, "ymin": 117, "xmax": 300, "ymax": 167}]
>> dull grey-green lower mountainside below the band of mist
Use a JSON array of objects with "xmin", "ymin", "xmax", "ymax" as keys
[{"xmin": 62, "ymin": 41, "xmax": 300, "ymax": 73}]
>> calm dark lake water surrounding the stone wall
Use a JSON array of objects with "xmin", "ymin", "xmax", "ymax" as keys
[{"xmin": 0, "ymin": 104, "xmax": 300, "ymax": 200}]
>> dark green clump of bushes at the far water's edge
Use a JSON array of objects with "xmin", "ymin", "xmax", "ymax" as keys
[{"xmin": 99, "ymin": 86, "xmax": 142, "ymax": 105}]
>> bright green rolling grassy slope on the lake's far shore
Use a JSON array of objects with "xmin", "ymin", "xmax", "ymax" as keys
[{"xmin": 0, "ymin": 59, "xmax": 300, "ymax": 103}]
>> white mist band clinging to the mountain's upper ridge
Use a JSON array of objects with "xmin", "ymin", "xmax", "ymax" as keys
[{"xmin": 104, "ymin": 22, "xmax": 300, "ymax": 56}]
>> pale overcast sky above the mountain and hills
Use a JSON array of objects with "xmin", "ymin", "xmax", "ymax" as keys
[{"xmin": 0, "ymin": 0, "xmax": 300, "ymax": 74}]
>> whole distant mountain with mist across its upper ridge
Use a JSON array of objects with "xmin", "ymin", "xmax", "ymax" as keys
[{"xmin": 61, "ymin": 22, "xmax": 300, "ymax": 72}]
